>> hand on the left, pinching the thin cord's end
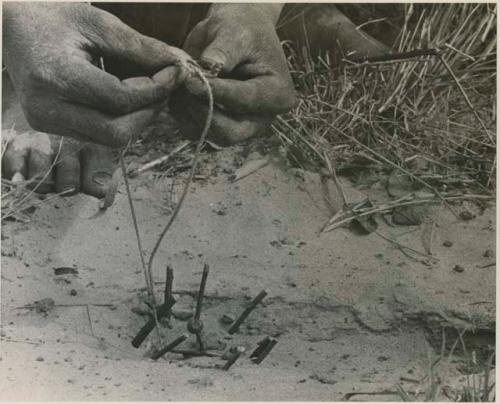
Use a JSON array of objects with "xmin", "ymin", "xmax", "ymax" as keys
[{"xmin": 3, "ymin": 2, "xmax": 189, "ymax": 147}]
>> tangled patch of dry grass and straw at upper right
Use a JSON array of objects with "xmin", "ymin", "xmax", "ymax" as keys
[{"xmin": 274, "ymin": 3, "xmax": 496, "ymax": 199}]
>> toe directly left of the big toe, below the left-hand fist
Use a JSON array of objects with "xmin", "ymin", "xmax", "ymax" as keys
[{"xmin": 54, "ymin": 138, "xmax": 82, "ymax": 196}]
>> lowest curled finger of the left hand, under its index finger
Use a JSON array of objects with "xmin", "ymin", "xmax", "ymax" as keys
[{"xmin": 24, "ymin": 98, "xmax": 163, "ymax": 147}]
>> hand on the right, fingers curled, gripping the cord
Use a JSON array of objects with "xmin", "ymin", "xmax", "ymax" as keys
[{"xmin": 170, "ymin": 4, "xmax": 296, "ymax": 145}]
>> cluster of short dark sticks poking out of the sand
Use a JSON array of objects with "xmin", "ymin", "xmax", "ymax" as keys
[{"xmin": 132, "ymin": 264, "xmax": 278, "ymax": 370}]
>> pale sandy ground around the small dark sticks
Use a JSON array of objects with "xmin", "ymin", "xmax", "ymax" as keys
[{"xmin": 0, "ymin": 76, "xmax": 495, "ymax": 400}]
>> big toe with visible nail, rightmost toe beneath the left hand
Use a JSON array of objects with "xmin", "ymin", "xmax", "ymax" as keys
[{"xmin": 81, "ymin": 144, "xmax": 113, "ymax": 198}]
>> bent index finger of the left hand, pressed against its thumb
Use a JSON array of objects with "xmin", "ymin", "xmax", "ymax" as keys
[{"xmin": 55, "ymin": 57, "xmax": 185, "ymax": 115}]
